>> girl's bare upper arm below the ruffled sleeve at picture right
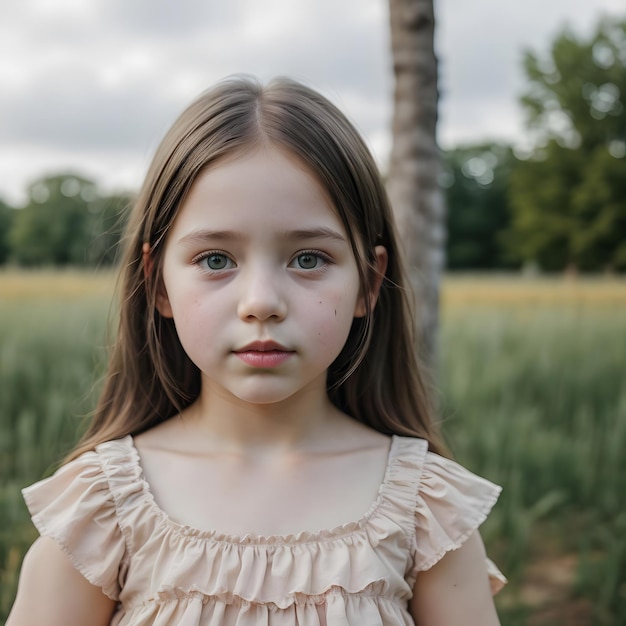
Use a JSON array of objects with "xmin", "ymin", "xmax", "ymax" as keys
[{"xmin": 409, "ymin": 531, "xmax": 500, "ymax": 626}]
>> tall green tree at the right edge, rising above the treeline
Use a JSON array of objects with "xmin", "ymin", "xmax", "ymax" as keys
[{"xmin": 507, "ymin": 18, "xmax": 626, "ymax": 270}]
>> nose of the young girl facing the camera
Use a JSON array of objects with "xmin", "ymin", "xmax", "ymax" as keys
[{"xmin": 237, "ymin": 269, "xmax": 287, "ymax": 321}]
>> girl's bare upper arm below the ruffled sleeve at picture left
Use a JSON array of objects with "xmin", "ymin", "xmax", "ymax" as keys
[{"xmin": 6, "ymin": 537, "xmax": 116, "ymax": 626}]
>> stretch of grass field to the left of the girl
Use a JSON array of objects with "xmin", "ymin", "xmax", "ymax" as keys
[{"xmin": 0, "ymin": 272, "xmax": 112, "ymax": 612}]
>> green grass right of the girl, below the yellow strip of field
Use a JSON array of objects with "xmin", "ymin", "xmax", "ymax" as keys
[{"xmin": 440, "ymin": 308, "xmax": 626, "ymax": 624}]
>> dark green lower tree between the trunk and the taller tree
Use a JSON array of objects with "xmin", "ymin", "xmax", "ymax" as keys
[{"xmin": 443, "ymin": 144, "xmax": 516, "ymax": 269}]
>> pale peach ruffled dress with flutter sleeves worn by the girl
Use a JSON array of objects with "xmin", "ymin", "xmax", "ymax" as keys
[{"xmin": 23, "ymin": 436, "xmax": 506, "ymax": 626}]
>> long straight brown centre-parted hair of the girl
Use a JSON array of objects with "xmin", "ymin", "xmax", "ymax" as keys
[{"xmin": 69, "ymin": 77, "xmax": 445, "ymax": 459}]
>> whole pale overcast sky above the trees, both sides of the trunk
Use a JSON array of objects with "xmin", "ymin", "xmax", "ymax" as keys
[{"xmin": 0, "ymin": 0, "xmax": 626, "ymax": 204}]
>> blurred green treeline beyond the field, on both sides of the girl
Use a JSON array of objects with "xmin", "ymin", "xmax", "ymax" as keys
[{"xmin": 0, "ymin": 18, "xmax": 626, "ymax": 272}]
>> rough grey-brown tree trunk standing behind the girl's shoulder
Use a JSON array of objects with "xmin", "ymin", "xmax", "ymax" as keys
[{"xmin": 387, "ymin": 0, "xmax": 445, "ymax": 366}]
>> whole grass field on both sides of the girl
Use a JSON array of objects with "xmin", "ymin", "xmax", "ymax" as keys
[{"xmin": 0, "ymin": 272, "xmax": 626, "ymax": 626}]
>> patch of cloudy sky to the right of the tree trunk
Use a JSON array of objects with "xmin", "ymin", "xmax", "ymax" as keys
[{"xmin": 435, "ymin": 0, "xmax": 626, "ymax": 147}]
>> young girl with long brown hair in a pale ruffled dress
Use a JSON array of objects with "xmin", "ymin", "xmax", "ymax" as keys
[{"xmin": 9, "ymin": 79, "xmax": 503, "ymax": 626}]
